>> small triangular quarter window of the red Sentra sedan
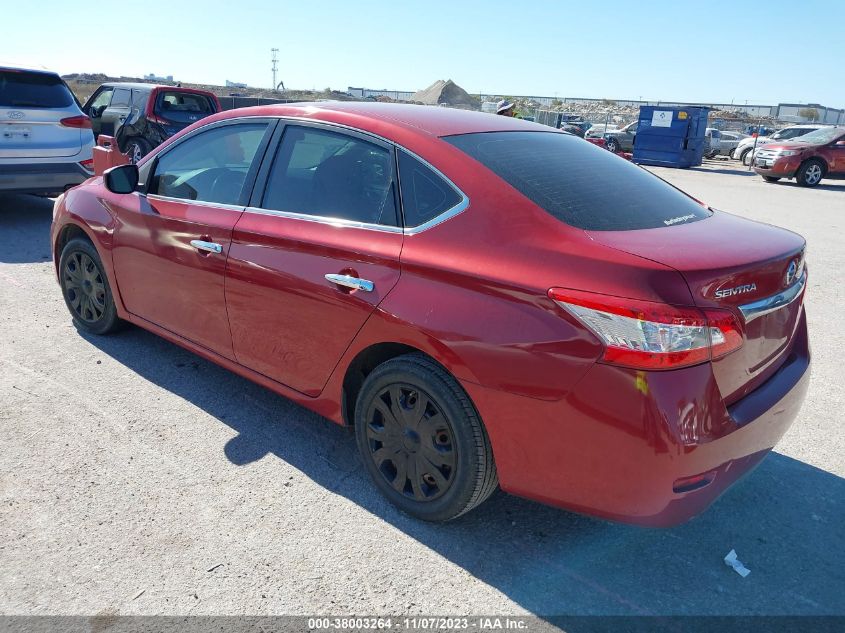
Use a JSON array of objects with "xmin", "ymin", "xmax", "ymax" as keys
[{"xmin": 399, "ymin": 151, "xmax": 462, "ymax": 228}]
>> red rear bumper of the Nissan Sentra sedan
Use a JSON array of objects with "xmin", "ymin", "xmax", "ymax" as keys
[{"xmin": 464, "ymin": 312, "xmax": 810, "ymax": 527}]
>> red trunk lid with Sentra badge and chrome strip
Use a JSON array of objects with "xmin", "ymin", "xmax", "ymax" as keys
[{"xmin": 588, "ymin": 211, "xmax": 805, "ymax": 404}]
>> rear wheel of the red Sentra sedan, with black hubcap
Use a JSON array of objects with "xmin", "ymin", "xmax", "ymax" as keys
[{"xmin": 355, "ymin": 353, "xmax": 499, "ymax": 521}]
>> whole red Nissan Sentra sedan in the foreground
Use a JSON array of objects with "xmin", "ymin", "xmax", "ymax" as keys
[{"xmin": 51, "ymin": 103, "xmax": 810, "ymax": 526}]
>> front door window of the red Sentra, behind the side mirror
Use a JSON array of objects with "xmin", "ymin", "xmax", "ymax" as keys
[{"xmin": 147, "ymin": 123, "xmax": 267, "ymax": 204}]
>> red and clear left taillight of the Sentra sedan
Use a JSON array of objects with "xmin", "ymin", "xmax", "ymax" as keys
[{"xmin": 549, "ymin": 288, "xmax": 742, "ymax": 369}]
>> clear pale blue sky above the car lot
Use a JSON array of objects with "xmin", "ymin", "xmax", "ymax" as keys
[{"xmin": 0, "ymin": 0, "xmax": 845, "ymax": 108}]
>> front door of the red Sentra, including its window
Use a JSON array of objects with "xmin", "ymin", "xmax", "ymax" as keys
[{"xmin": 112, "ymin": 119, "xmax": 275, "ymax": 359}]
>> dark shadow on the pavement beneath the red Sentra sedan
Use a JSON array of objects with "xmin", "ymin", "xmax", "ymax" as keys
[{"xmin": 82, "ymin": 328, "xmax": 845, "ymax": 616}]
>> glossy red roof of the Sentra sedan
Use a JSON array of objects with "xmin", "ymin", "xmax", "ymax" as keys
[{"xmin": 215, "ymin": 101, "xmax": 559, "ymax": 136}]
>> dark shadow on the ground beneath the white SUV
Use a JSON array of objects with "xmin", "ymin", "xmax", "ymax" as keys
[{"xmin": 0, "ymin": 194, "xmax": 53, "ymax": 264}]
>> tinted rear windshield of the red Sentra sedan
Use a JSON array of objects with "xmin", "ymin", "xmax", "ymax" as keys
[{"xmin": 443, "ymin": 132, "xmax": 710, "ymax": 231}]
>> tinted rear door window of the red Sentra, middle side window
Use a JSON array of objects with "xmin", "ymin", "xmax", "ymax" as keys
[{"xmin": 261, "ymin": 125, "xmax": 398, "ymax": 226}]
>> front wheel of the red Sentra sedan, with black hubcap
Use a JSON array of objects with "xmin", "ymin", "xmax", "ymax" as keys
[{"xmin": 59, "ymin": 238, "xmax": 123, "ymax": 334}]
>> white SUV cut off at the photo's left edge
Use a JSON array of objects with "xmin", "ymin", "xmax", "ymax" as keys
[{"xmin": 0, "ymin": 64, "xmax": 94, "ymax": 194}]
